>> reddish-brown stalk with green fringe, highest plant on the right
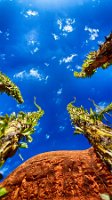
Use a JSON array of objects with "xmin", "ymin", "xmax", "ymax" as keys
[{"xmin": 74, "ymin": 33, "xmax": 112, "ymax": 78}]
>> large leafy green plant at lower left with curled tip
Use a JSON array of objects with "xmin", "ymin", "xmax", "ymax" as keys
[{"xmin": 0, "ymin": 97, "xmax": 44, "ymax": 166}]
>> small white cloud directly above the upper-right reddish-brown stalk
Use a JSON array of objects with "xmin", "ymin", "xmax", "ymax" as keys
[{"xmin": 84, "ymin": 26, "xmax": 99, "ymax": 40}]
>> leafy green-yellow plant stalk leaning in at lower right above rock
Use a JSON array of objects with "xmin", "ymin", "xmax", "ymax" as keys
[{"xmin": 67, "ymin": 98, "xmax": 112, "ymax": 170}]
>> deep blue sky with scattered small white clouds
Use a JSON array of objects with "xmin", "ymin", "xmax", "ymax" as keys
[{"xmin": 0, "ymin": 0, "xmax": 112, "ymax": 176}]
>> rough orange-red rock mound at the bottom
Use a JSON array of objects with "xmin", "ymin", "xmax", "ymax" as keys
[{"xmin": 0, "ymin": 148, "xmax": 112, "ymax": 200}]
